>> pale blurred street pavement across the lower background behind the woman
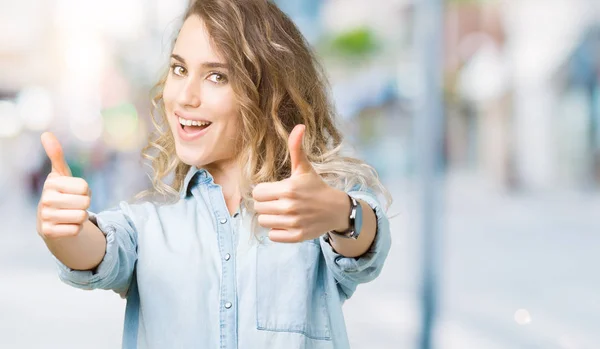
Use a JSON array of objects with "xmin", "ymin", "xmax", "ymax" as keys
[{"xmin": 0, "ymin": 175, "xmax": 600, "ymax": 349}]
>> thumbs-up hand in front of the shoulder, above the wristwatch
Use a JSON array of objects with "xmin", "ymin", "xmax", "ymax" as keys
[{"xmin": 252, "ymin": 125, "xmax": 350, "ymax": 242}]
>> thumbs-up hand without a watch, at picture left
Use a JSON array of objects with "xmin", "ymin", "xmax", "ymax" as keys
[{"xmin": 37, "ymin": 132, "xmax": 91, "ymax": 240}]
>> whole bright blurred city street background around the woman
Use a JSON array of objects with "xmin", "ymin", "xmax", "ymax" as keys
[{"xmin": 0, "ymin": 0, "xmax": 600, "ymax": 349}]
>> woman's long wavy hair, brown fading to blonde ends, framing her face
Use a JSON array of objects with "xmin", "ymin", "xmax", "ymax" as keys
[{"xmin": 138, "ymin": 0, "xmax": 392, "ymax": 207}]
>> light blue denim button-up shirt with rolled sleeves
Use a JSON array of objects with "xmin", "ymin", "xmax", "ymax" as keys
[{"xmin": 52, "ymin": 167, "xmax": 391, "ymax": 349}]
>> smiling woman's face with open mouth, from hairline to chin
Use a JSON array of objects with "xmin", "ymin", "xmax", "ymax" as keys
[{"xmin": 163, "ymin": 15, "xmax": 239, "ymax": 167}]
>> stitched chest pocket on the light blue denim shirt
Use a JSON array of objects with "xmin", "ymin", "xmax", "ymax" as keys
[{"xmin": 256, "ymin": 239, "xmax": 331, "ymax": 340}]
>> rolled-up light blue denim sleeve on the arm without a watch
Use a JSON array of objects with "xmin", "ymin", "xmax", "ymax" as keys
[{"xmin": 54, "ymin": 202, "xmax": 137, "ymax": 298}]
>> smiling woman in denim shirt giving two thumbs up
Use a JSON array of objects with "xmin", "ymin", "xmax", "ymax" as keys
[{"xmin": 38, "ymin": 0, "xmax": 390, "ymax": 349}]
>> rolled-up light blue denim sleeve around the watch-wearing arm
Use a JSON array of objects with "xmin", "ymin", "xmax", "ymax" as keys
[{"xmin": 319, "ymin": 190, "xmax": 391, "ymax": 299}]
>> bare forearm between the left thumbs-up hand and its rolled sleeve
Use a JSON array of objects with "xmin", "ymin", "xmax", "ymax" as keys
[{"xmin": 44, "ymin": 220, "xmax": 106, "ymax": 270}]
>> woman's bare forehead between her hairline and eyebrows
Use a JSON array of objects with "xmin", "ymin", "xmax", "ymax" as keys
[{"xmin": 173, "ymin": 15, "xmax": 222, "ymax": 64}]
